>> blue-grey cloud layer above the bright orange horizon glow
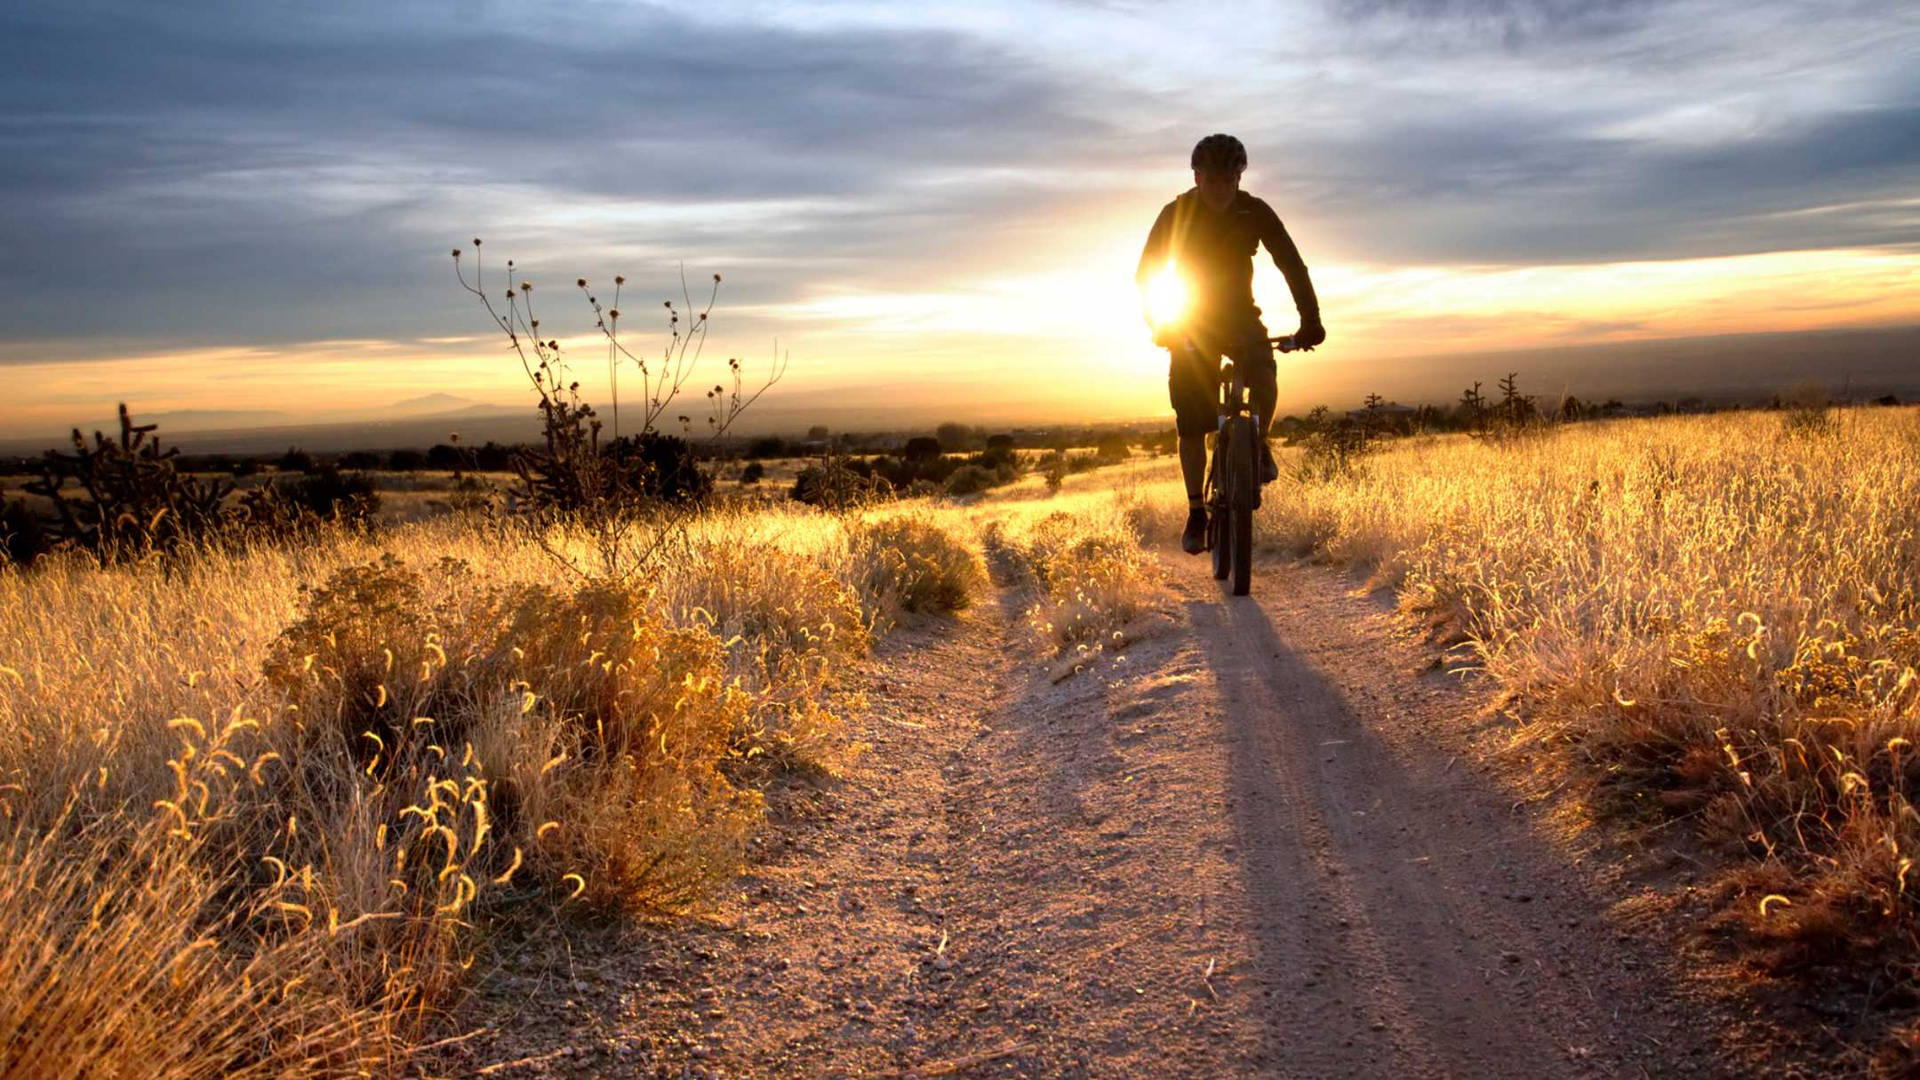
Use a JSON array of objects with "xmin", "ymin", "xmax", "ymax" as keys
[{"xmin": 0, "ymin": 0, "xmax": 1920, "ymax": 363}]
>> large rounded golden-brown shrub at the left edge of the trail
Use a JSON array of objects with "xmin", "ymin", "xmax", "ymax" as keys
[{"xmin": 263, "ymin": 555, "xmax": 758, "ymax": 909}]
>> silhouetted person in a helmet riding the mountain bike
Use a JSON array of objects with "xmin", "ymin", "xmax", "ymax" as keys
[{"xmin": 1135, "ymin": 135, "xmax": 1327, "ymax": 555}]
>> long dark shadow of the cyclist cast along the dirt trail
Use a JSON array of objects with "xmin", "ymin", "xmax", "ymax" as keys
[{"xmin": 1187, "ymin": 580, "xmax": 1643, "ymax": 1076}]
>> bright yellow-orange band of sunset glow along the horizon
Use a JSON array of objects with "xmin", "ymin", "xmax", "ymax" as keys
[{"xmin": 0, "ymin": 240, "xmax": 1920, "ymax": 430}]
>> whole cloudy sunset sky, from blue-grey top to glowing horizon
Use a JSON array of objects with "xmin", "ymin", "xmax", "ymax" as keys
[{"xmin": 0, "ymin": 0, "xmax": 1920, "ymax": 432}]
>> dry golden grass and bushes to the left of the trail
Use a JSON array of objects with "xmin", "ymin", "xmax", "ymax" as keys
[{"xmin": 0, "ymin": 472, "xmax": 1152, "ymax": 1080}]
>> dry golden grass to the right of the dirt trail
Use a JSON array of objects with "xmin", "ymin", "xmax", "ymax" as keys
[{"xmin": 1258, "ymin": 409, "xmax": 1920, "ymax": 980}]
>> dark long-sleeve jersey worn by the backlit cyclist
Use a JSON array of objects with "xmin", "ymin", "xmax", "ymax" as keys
[{"xmin": 1135, "ymin": 188, "xmax": 1319, "ymax": 331}]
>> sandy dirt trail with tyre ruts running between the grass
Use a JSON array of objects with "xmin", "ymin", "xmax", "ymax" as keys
[{"xmin": 456, "ymin": 553, "xmax": 1793, "ymax": 1078}]
